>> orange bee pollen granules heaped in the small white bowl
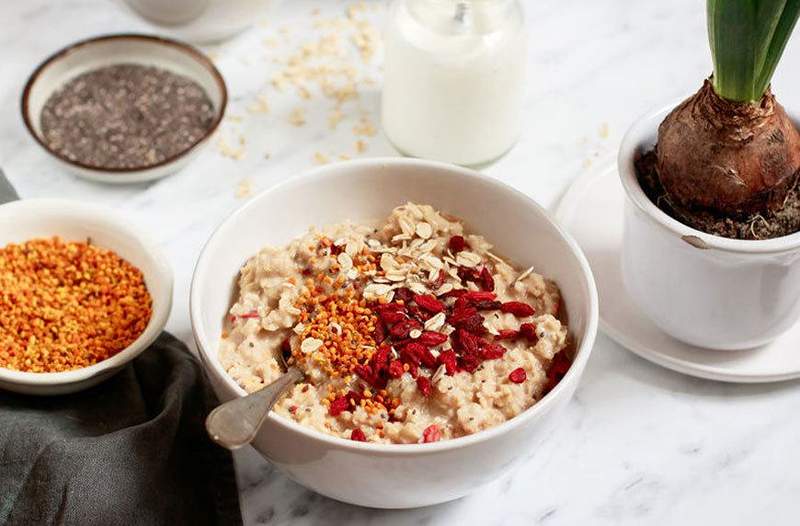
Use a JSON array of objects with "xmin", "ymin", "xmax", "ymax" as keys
[{"xmin": 0, "ymin": 238, "xmax": 152, "ymax": 372}]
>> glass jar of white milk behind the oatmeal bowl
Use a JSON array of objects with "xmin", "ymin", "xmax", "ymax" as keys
[{"xmin": 381, "ymin": 0, "xmax": 527, "ymax": 166}]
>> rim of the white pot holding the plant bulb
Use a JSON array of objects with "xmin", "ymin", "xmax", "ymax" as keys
[{"xmin": 617, "ymin": 97, "xmax": 800, "ymax": 254}]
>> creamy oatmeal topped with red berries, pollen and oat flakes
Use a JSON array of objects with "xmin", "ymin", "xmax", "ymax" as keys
[{"xmin": 220, "ymin": 203, "xmax": 569, "ymax": 444}]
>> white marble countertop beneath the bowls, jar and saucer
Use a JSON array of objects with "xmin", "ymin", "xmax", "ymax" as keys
[{"xmin": 0, "ymin": 0, "xmax": 800, "ymax": 525}]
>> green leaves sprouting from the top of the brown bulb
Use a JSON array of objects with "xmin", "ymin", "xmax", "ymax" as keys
[{"xmin": 707, "ymin": 0, "xmax": 800, "ymax": 101}]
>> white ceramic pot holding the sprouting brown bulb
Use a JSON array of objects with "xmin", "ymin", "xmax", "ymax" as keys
[{"xmin": 618, "ymin": 102, "xmax": 800, "ymax": 350}]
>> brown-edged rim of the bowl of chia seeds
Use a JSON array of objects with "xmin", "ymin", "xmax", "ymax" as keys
[{"xmin": 20, "ymin": 33, "xmax": 228, "ymax": 176}]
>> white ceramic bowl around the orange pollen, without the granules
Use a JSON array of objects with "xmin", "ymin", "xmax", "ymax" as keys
[{"xmin": 0, "ymin": 199, "xmax": 173, "ymax": 395}]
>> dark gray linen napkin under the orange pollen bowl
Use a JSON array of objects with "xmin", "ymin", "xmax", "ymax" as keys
[{"xmin": 0, "ymin": 171, "xmax": 242, "ymax": 526}]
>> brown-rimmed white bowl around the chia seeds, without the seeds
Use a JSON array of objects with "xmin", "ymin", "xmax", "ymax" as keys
[{"xmin": 22, "ymin": 34, "xmax": 228, "ymax": 184}]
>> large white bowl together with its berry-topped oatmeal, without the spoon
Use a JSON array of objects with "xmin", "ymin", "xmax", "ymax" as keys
[{"xmin": 190, "ymin": 159, "xmax": 597, "ymax": 508}]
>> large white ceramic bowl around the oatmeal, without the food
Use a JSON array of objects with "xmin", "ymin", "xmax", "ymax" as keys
[{"xmin": 190, "ymin": 159, "xmax": 598, "ymax": 508}]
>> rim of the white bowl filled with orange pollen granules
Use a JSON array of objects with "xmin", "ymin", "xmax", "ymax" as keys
[{"xmin": 0, "ymin": 198, "xmax": 174, "ymax": 386}]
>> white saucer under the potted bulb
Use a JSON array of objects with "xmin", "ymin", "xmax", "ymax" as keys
[{"xmin": 556, "ymin": 164, "xmax": 800, "ymax": 383}]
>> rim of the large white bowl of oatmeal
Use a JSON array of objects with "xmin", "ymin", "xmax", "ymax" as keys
[{"xmin": 189, "ymin": 157, "xmax": 599, "ymax": 456}]
